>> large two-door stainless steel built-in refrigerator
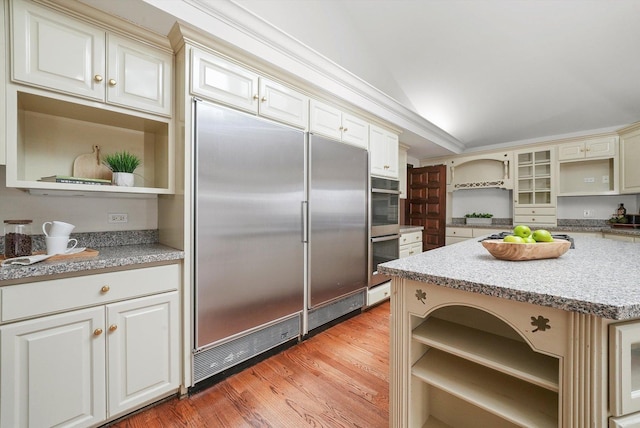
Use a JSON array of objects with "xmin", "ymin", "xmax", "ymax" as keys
[{"xmin": 193, "ymin": 101, "xmax": 368, "ymax": 382}]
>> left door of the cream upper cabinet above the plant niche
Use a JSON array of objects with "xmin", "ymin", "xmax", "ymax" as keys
[{"xmin": 12, "ymin": 1, "xmax": 105, "ymax": 101}]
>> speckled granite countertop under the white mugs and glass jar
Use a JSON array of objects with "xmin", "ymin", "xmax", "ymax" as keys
[{"xmin": 0, "ymin": 243, "xmax": 184, "ymax": 286}]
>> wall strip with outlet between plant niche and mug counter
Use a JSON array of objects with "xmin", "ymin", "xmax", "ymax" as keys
[{"xmin": 0, "ymin": 165, "xmax": 158, "ymax": 234}]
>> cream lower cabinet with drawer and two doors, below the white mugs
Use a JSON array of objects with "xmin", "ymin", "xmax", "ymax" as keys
[{"xmin": 0, "ymin": 265, "xmax": 180, "ymax": 428}]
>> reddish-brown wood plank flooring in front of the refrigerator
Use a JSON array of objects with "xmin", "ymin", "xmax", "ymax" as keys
[{"xmin": 111, "ymin": 302, "xmax": 390, "ymax": 428}]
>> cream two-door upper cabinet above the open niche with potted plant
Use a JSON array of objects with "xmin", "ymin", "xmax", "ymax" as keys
[{"xmin": 12, "ymin": 0, "xmax": 173, "ymax": 116}]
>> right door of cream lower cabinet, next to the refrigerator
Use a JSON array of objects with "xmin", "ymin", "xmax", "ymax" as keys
[{"xmin": 107, "ymin": 292, "xmax": 180, "ymax": 417}]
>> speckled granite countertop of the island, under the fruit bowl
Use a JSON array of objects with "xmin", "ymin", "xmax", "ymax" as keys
[{"xmin": 378, "ymin": 236, "xmax": 640, "ymax": 320}]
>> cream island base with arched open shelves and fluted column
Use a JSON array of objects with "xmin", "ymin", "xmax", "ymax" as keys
[{"xmin": 390, "ymin": 278, "xmax": 584, "ymax": 428}]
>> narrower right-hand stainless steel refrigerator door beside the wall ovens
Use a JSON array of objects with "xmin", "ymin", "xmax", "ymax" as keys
[{"xmin": 308, "ymin": 134, "xmax": 369, "ymax": 308}]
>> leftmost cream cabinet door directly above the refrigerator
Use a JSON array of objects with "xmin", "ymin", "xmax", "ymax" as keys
[{"xmin": 191, "ymin": 49, "xmax": 258, "ymax": 114}]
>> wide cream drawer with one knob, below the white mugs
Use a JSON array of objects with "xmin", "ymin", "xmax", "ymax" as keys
[{"xmin": 0, "ymin": 264, "xmax": 180, "ymax": 322}]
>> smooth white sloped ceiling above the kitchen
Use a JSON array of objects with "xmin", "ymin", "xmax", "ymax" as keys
[{"xmin": 82, "ymin": 0, "xmax": 640, "ymax": 158}]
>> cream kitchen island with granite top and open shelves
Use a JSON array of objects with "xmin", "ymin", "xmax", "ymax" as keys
[{"xmin": 379, "ymin": 236, "xmax": 640, "ymax": 427}]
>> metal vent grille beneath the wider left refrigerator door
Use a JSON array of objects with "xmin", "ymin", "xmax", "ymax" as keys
[{"xmin": 193, "ymin": 316, "xmax": 300, "ymax": 382}]
